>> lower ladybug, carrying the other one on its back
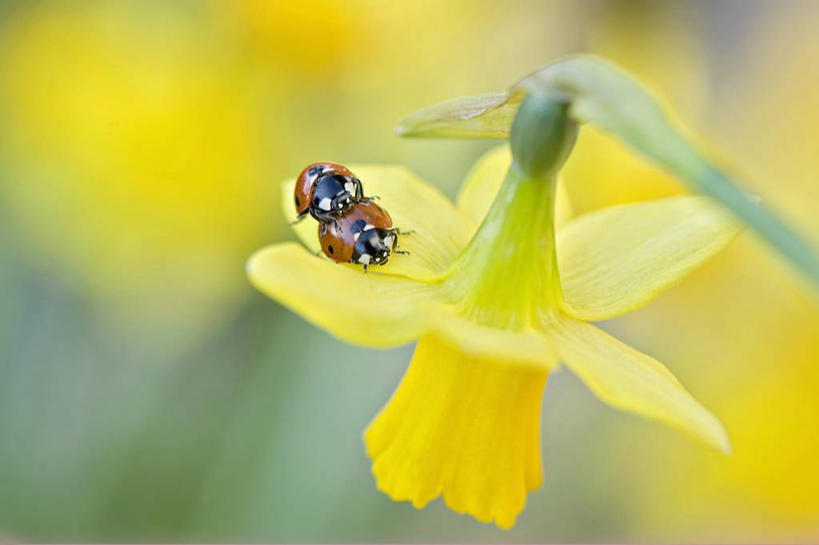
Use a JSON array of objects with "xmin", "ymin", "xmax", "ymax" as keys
[{"xmin": 318, "ymin": 202, "xmax": 409, "ymax": 272}]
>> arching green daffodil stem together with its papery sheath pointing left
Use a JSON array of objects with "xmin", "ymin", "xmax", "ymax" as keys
[{"xmin": 396, "ymin": 55, "xmax": 819, "ymax": 286}]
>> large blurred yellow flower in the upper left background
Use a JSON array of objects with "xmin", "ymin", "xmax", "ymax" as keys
[{"xmin": 0, "ymin": 3, "xmax": 276, "ymax": 342}]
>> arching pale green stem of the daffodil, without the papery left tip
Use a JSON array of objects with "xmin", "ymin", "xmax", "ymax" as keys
[{"xmin": 515, "ymin": 56, "xmax": 819, "ymax": 285}]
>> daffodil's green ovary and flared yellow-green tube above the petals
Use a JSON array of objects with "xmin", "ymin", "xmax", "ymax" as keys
[{"xmin": 449, "ymin": 96, "xmax": 577, "ymax": 330}]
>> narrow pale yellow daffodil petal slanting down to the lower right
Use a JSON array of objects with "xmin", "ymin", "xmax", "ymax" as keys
[{"xmin": 545, "ymin": 316, "xmax": 731, "ymax": 453}]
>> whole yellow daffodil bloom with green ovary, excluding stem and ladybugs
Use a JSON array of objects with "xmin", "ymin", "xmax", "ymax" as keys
[{"xmin": 248, "ymin": 97, "xmax": 740, "ymax": 528}]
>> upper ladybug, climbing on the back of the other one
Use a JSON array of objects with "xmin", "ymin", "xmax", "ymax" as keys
[{"xmin": 293, "ymin": 163, "xmax": 369, "ymax": 225}]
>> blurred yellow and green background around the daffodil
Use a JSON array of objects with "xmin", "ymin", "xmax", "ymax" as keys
[{"xmin": 0, "ymin": 0, "xmax": 819, "ymax": 542}]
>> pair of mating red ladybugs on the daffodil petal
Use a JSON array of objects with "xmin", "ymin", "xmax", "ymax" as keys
[{"xmin": 294, "ymin": 163, "xmax": 408, "ymax": 272}]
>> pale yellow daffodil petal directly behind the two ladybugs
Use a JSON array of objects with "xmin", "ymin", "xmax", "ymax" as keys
[{"xmin": 282, "ymin": 165, "xmax": 474, "ymax": 280}]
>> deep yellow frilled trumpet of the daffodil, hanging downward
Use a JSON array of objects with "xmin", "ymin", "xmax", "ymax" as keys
[{"xmin": 364, "ymin": 337, "xmax": 547, "ymax": 528}]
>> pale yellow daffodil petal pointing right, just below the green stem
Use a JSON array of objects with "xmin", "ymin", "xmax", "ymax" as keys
[{"xmin": 557, "ymin": 197, "xmax": 741, "ymax": 320}]
